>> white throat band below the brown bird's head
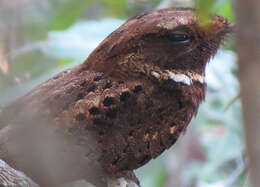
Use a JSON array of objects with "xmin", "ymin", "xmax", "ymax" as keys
[{"xmin": 151, "ymin": 70, "xmax": 205, "ymax": 86}]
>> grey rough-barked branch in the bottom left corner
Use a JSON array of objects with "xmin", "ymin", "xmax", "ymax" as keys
[{"xmin": 0, "ymin": 160, "xmax": 40, "ymax": 187}]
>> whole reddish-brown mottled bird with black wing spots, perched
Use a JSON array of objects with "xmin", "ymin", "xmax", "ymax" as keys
[{"xmin": 0, "ymin": 8, "xmax": 232, "ymax": 187}]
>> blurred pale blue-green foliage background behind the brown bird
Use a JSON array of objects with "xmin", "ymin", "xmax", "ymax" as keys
[{"xmin": 0, "ymin": 0, "xmax": 247, "ymax": 187}]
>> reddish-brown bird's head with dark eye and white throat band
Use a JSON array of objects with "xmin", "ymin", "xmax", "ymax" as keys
[{"xmin": 84, "ymin": 8, "xmax": 231, "ymax": 84}]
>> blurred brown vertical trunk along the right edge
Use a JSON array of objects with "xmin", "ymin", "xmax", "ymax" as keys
[{"xmin": 236, "ymin": 0, "xmax": 260, "ymax": 186}]
